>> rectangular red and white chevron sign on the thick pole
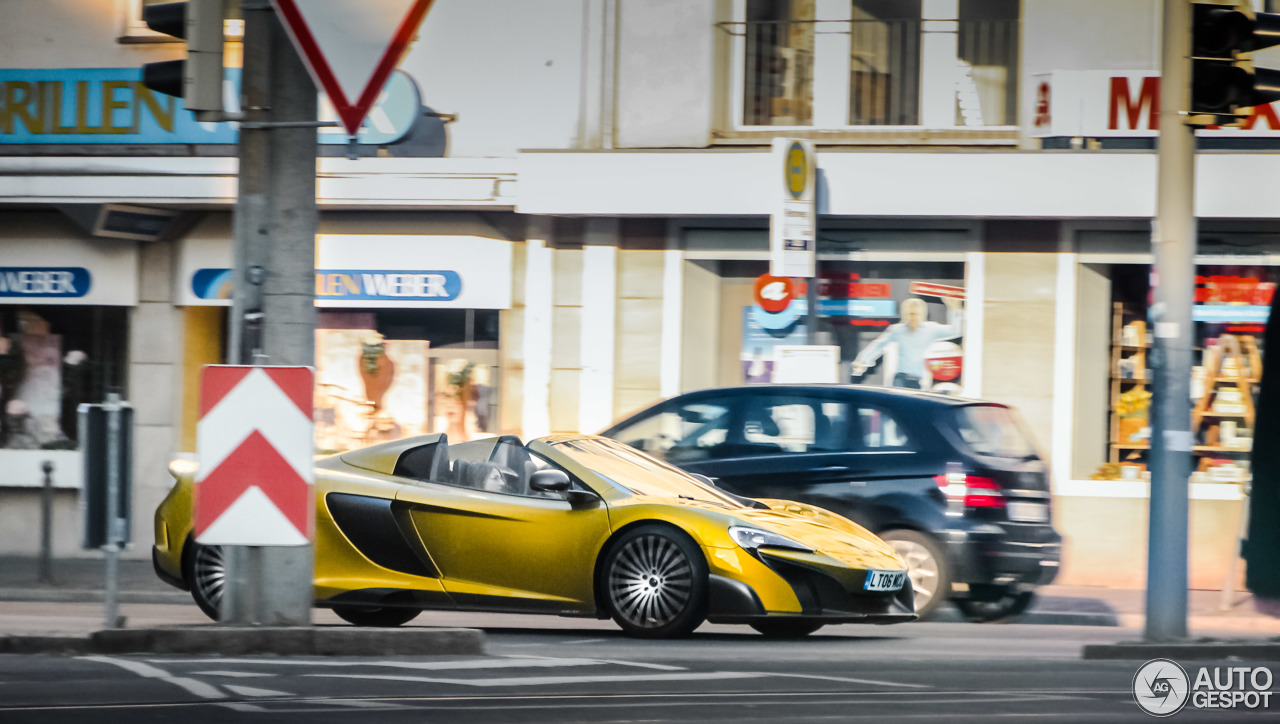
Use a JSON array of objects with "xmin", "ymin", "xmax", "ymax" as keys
[{"xmin": 195, "ymin": 365, "xmax": 315, "ymax": 546}]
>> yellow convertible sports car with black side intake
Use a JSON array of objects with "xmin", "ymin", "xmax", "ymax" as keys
[{"xmin": 152, "ymin": 435, "xmax": 915, "ymax": 637}]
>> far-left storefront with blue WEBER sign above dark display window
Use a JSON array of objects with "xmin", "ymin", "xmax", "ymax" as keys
[{"xmin": 0, "ymin": 221, "xmax": 138, "ymax": 487}]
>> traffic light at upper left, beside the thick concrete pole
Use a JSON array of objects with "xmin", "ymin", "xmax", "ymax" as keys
[{"xmin": 142, "ymin": 0, "xmax": 223, "ymax": 113}]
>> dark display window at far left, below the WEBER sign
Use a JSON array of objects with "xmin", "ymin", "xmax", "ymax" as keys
[{"xmin": 0, "ymin": 304, "xmax": 128, "ymax": 450}]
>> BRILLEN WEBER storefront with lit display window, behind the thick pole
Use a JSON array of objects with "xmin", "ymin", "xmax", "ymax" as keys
[{"xmin": 178, "ymin": 219, "xmax": 512, "ymax": 450}]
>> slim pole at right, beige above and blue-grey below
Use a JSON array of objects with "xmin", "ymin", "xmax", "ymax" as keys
[{"xmin": 1143, "ymin": 0, "xmax": 1196, "ymax": 641}]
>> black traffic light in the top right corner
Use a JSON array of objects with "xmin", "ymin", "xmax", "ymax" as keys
[{"xmin": 1190, "ymin": 3, "xmax": 1280, "ymax": 125}]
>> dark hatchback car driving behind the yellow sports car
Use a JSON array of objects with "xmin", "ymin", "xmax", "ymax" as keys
[{"xmin": 600, "ymin": 385, "xmax": 1061, "ymax": 620}]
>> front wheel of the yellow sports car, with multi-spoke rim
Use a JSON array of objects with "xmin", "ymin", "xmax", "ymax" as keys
[{"xmin": 603, "ymin": 524, "xmax": 707, "ymax": 638}]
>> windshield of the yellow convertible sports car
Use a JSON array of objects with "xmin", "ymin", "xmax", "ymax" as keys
[{"xmin": 554, "ymin": 439, "xmax": 742, "ymax": 508}]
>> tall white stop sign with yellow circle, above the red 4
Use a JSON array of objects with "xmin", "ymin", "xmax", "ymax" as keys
[{"xmin": 769, "ymin": 138, "xmax": 818, "ymax": 278}]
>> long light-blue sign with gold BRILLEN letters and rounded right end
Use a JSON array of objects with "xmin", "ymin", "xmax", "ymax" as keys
[{"xmin": 0, "ymin": 68, "xmax": 422, "ymax": 145}]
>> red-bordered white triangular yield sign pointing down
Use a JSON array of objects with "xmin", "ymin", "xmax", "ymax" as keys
[{"xmin": 271, "ymin": 0, "xmax": 431, "ymax": 136}]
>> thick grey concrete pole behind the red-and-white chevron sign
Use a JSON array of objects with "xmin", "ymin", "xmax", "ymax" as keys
[{"xmin": 221, "ymin": 0, "xmax": 317, "ymax": 626}]
